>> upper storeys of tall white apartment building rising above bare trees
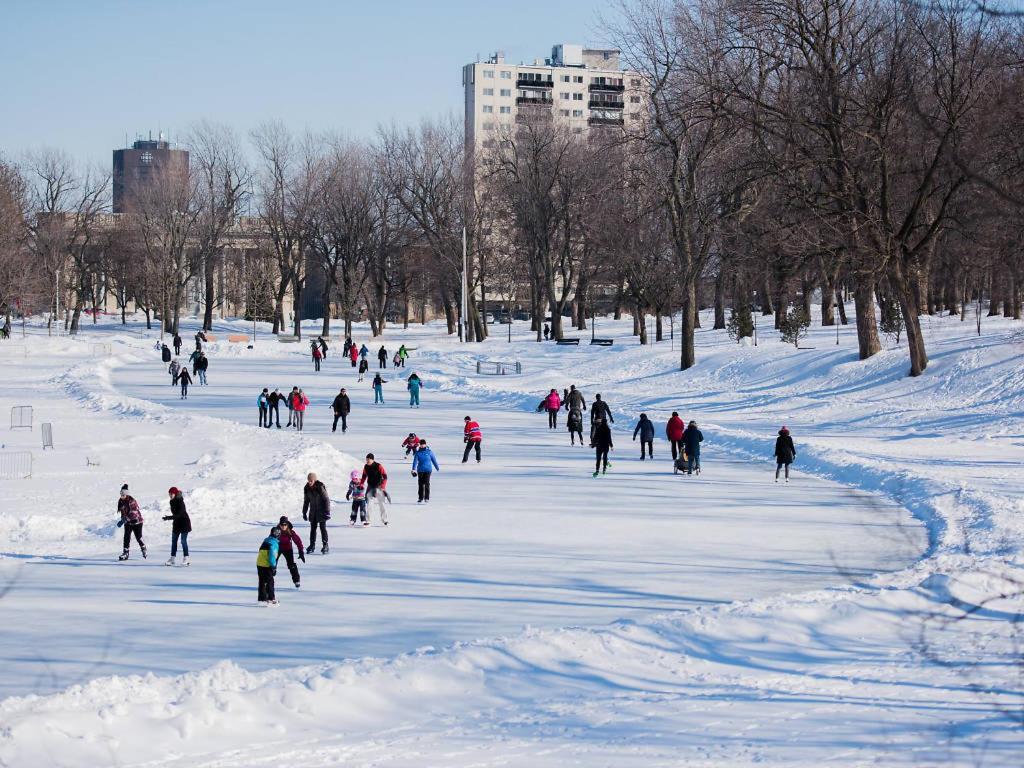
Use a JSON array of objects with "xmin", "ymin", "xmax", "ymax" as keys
[{"xmin": 462, "ymin": 44, "xmax": 643, "ymax": 152}]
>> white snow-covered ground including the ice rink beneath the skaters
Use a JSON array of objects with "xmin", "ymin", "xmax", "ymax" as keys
[{"xmin": 0, "ymin": 309, "xmax": 1024, "ymax": 766}]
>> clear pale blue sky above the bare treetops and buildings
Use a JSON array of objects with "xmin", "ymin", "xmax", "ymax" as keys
[{"xmin": 0, "ymin": 0, "xmax": 615, "ymax": 165}]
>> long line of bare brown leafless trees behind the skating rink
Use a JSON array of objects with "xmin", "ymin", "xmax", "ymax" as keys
[{"xmin": 0, "ymin": 0, "xmax": 1024, "ymax": 376}]
